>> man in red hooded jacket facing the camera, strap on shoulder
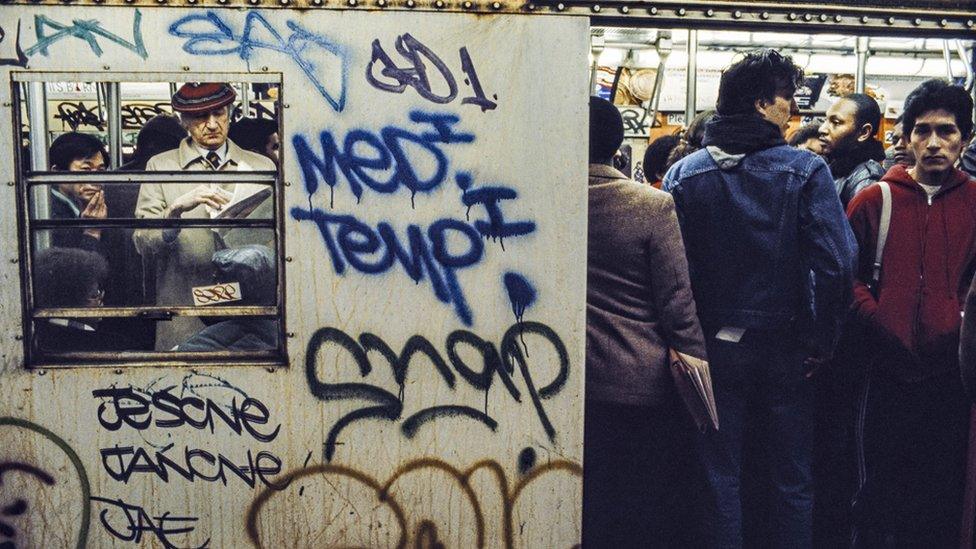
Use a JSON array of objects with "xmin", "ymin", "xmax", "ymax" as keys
[{"xmin": 847, "ymin": 80, "xmax": 976, "ymax": 547}]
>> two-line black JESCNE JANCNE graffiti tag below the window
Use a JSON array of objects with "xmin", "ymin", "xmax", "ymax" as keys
[{"xmin": 92, "ymin": 374, "xmax": 282, "ymax": 488}]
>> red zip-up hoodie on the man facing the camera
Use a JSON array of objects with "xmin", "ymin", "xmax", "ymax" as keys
[{"xmin": 847, "ymin": 165, "xmax": 976, "ymax": 381}]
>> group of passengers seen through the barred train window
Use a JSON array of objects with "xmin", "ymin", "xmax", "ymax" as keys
[{"xmin": 33, "ymin": 83, "xmax": 279, "ymax": 352}]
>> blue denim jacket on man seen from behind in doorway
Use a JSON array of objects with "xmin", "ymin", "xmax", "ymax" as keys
[{"xmin": 663, "ymin": 145, "xmax": 857, "ymax": 357}]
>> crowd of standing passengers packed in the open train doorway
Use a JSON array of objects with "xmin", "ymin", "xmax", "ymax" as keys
[{"xmin": 583, "ymin": 50, "xmax": 976, "ymax": 548}]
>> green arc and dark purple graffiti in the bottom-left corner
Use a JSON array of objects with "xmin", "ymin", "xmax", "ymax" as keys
[{"xmin": 0, "ymin": 417, "xmax": 91, "ymax": 549}]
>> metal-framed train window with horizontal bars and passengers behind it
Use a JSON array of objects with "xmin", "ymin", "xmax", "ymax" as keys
[{"xmin": 13, "ymin": 72, "xmax": 286, "ymax": 367}]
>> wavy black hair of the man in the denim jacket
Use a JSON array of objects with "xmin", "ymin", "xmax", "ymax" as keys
[{"xmin": 715, "ymin": 49, "xmax": 803, "ymax": 115}]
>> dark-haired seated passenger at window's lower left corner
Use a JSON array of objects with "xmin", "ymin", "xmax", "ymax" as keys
[{"xmin": 34, "ymin": 248, "xmax": 133, "ymax": 352}]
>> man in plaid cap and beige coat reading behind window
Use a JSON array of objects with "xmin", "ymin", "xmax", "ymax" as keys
[{"xmin": 133, "ymin": 82, "xmax": 276, "ymax": 350}]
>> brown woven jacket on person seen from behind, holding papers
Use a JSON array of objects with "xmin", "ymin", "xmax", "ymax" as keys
[{"xmin": 586, "ymin": 164, "xmax": 705, "ymax": 406}]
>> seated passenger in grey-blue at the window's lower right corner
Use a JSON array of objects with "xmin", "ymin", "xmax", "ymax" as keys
[{"xmin": 176, "ymin": 244, "xmax": 278, "ymax": 351}]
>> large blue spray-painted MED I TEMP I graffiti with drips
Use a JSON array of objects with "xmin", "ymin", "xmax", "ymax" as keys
[{"xmin": 291, "ymin": 111, "xmax": 536, "ymax": 326}]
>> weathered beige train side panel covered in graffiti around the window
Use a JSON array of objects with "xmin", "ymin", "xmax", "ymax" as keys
[{"xmin": 0, "ymin": 6, "xmax": 587, "ymax": 547}]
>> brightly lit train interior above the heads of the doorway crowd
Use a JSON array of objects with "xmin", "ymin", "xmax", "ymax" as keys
[{"xmin": 590, "ymin": 26, "xmax": 976, "ymax": 184}]
